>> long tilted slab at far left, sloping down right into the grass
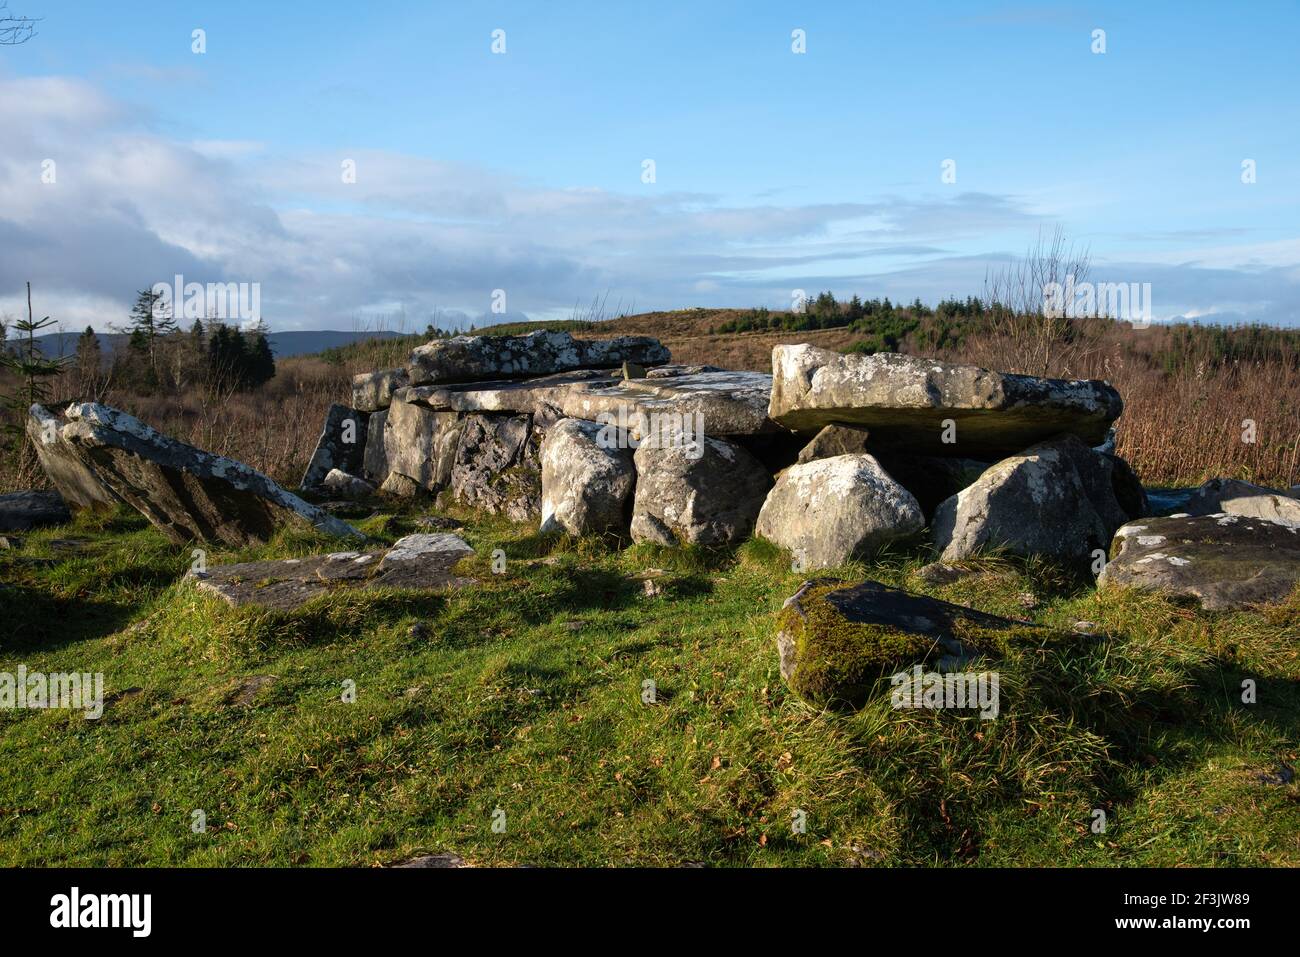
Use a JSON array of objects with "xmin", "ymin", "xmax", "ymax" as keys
[{"xmin": 60, "ymin": 402, "xmax": 360, "ymax": 547}]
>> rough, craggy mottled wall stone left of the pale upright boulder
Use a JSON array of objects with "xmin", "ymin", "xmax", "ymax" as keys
[{"xmin": 450, "ymin": 415, "xmax": 542, "ymax": 521}]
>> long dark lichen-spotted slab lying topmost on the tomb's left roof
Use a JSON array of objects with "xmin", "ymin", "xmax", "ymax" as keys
[{"xmin": 407, "ymin": 330, "xmax": 670, "ymax": 385}]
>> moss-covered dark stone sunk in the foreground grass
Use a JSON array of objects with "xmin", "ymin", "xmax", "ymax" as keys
[{"xmin": 776, "ymin": 579, "xmax": 1048, "ymax": 707}]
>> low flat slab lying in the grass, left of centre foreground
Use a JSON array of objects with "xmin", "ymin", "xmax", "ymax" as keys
[{"xmin": 187, "ymin": 534, "xmax": 475, "ymax": 610}]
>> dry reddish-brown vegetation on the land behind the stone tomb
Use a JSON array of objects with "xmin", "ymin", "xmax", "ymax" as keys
[{"xmin": 0, "ymin": 309, "xmax": 1300, "ymax": 490}]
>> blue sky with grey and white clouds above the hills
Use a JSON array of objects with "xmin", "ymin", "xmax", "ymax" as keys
[{"xmin": 0, "ymin": 0, "xmax": 1300, "ymax": 332}]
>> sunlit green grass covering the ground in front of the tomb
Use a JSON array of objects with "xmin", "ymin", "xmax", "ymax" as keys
[{"xmin": 0, "ymin": 515, "xmax": 1300, "ymax": 866}]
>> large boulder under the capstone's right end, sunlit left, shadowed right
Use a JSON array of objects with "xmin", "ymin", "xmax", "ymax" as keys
[{"xmin": 932, "ymin": 436, "xmax": 1128, "ymax": 564}]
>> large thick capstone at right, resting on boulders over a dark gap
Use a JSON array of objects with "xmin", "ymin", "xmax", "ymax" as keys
[{"xmin": 768, "ymin": 345, "xmax": 1123, "ymax": 459}]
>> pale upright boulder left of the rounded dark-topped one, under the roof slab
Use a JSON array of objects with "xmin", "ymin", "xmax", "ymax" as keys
[{"xmin": 541, "ymin": 419, "xmax": 637, "ymax": 536}]
